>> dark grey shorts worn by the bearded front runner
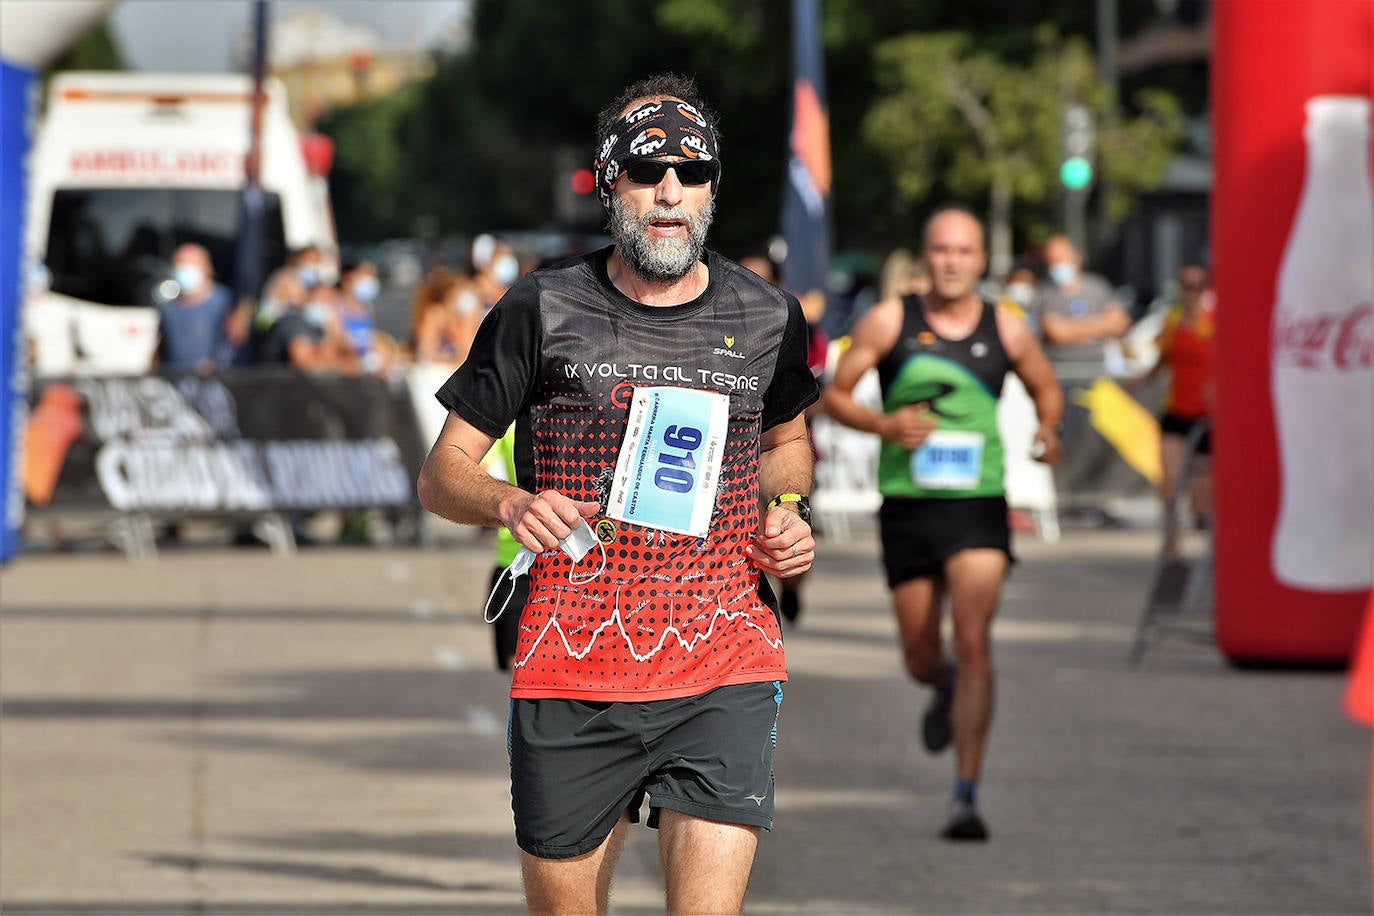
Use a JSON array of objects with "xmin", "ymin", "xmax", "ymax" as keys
[{"xmin": 508, "ymin": 681, "xmax": 782, "ymax": 858}]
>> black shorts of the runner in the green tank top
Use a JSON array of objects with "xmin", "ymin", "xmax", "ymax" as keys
[{"xmin": 878, "ymin": 496, "xmax": 1013, "ymax": 588}]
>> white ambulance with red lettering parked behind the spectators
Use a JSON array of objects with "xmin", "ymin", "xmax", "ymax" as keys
[{"xmin": 23, "ymin": 73, "xmax": 337, "ymax": 376}]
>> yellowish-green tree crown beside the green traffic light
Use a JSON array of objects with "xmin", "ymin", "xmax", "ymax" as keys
[{"xmin": 863, "ymin": 27, "xmax": 1183, "ymax": 266}]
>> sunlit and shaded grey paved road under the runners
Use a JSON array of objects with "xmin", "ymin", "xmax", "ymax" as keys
[{"xmin": 0, "ymin": 527, "xmax": 1370, "ymax": 916}]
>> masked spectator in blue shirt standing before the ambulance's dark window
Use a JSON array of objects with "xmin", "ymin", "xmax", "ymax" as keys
[{"xmin": 158, "ymin": 243, "xmax": 243, "ymax": 372}]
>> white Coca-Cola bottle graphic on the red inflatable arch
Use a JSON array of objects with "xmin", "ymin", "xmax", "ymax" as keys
[{"xmin": 1272, "ymin": 96, "xmax": 1374, "ymax": 592}]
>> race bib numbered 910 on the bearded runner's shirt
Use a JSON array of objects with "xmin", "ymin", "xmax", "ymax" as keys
[{"xmin": 606, "ymin": 387, "xmax": 730, "ymax": 537}]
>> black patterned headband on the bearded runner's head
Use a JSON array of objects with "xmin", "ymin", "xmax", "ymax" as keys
[{"xmin": 594, "ymin": 99, "xmax": 720, "ymax": 206}]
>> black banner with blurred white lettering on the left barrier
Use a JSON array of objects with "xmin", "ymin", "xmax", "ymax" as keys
[{"xmin": 22, "ymin": 371, "xmax": 425, "ymax": 515}]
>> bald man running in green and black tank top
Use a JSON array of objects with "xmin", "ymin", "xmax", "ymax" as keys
[{"xmin": 826, "ymin": 207, "xmax": 1063, "ymax": 840}]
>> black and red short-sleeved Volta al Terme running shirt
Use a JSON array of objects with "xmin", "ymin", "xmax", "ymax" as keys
[{"xmin": 438, "ymin": 249, "xmax": 819, "ymax": 700}]
